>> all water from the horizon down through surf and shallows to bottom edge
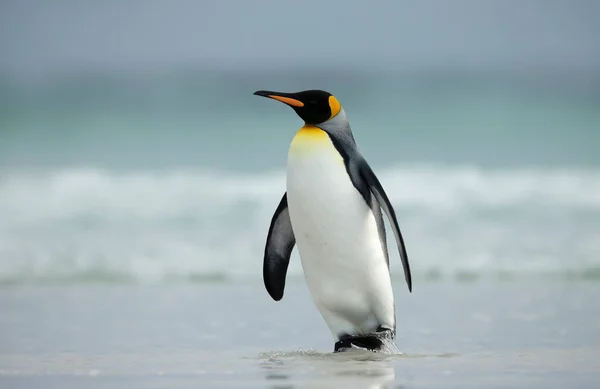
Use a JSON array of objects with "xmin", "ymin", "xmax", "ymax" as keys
[{"xmin": 0, "ymin": 69, "xmax": 600, "ymax": 389}]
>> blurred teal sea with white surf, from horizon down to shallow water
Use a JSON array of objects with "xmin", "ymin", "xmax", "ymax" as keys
[{"xmin": 0, "ymin": 69, "xmax": 600, "ymax": 284}]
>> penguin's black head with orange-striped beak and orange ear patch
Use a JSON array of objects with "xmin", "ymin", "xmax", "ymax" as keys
[{"xmin": 254, "ymin": 89, "xmax": 342, "ymax": 125}]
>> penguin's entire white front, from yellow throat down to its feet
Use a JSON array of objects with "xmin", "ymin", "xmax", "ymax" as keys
[{"xmin": 287, "ymin": 129, "xmax": 395, "ymax": 337}]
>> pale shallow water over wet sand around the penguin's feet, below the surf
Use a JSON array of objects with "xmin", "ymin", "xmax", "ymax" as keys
[{"xmin": 0, "ymin": 281, "xmax": 600, "ymax": 388}]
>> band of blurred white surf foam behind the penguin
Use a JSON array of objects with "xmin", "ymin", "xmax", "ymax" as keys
[{"xmin": 0, "ymin": 165, "xmax": 600, "ymax": 283}]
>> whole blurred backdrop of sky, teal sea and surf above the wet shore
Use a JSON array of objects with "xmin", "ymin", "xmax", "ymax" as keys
[{"xmin": 0, "ymin": 0, "xmax": 600, "ymax": 289}]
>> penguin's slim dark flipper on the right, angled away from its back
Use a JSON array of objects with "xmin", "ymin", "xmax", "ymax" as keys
[{"xmin": 356, "ymin": 155, "xmax": 412, "ymax": 292}]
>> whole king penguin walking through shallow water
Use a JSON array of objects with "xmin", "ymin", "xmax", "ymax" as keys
[{"xmin": 254, "ymin": 90, "xmax": 412, "ymax": 352}]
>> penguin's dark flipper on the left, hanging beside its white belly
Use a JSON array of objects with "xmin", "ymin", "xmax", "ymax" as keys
[{"xmin": 263, "ymin": 192, "xmax": 296, "ymax": 301}]
